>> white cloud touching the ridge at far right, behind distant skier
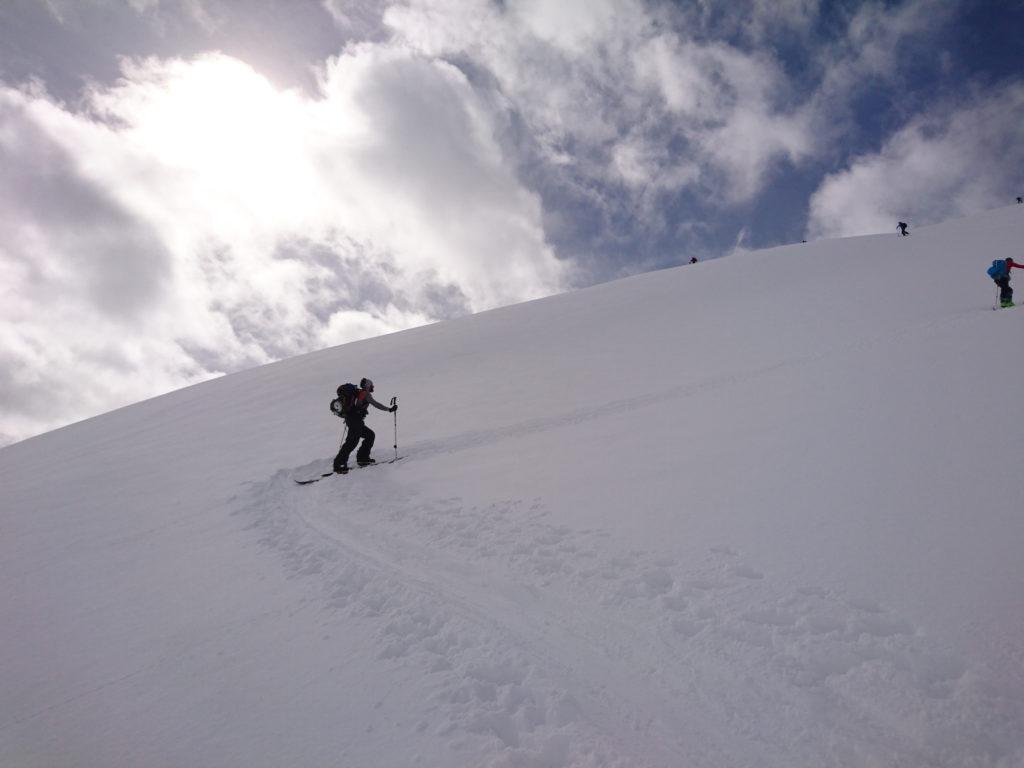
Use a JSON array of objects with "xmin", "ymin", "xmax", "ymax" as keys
[{"xmin": 808, "ymin": 84, "xmax": 1024, "ymax": 238}]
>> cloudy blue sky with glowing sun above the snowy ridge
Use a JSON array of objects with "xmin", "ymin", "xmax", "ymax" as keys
[{"xmin": 0, "ymin": 0, "xmax": 1024, "ymax": 444}]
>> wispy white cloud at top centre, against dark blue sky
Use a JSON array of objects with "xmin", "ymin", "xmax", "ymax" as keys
[{"xmin": 384, "ymin": 0, "xmax": 814, "ymax": 201}]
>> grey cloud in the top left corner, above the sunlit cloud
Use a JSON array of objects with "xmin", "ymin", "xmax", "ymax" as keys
[{"xmin": 0, "ymin": 0, "xmax": 352, "ymax": 102}]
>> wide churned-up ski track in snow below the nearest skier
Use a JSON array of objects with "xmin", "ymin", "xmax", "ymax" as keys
[{"xmin": 236, "ymin": 467, "xmax": 1024, "ymax": 768}]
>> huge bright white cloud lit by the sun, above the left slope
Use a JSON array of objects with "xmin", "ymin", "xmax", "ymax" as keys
[{"xmin": 0, "ymin": 45, "xmax": 565, "ymax": 439}]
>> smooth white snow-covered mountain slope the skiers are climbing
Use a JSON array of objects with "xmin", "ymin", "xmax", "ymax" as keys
[{"xmin": 6, "ymin": 207, "xmax": 1024, "ymax": 768}]
